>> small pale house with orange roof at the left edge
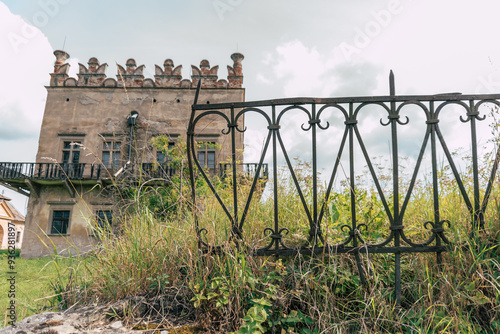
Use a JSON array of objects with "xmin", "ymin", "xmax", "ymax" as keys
[{"xmin": 0, "ymin": 194, "xmax": 24, "ymax": 249}]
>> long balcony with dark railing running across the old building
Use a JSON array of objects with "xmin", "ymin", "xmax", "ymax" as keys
[{"xmin": 0, "ymin": 162, "xmax": 269, "ymax": 196}]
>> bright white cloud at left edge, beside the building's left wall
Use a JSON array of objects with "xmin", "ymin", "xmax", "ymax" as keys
[{"xmin": 0, "ymin": 3, "xmax": 54, "ymax": 151}]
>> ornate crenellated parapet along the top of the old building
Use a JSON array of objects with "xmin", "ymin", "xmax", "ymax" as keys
[{"xmin": 50, "ymin": 50, "xmax": 244, "ymax": 89}]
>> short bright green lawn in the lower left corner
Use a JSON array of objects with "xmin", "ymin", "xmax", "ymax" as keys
[{"xmin": 0, "ymin": 254, "xmax": 79, "ymax": 327}]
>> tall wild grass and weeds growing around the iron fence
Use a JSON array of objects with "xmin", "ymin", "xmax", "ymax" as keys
[{"xmin": 0, "ymin": 147, "xmax": 500, "ymax": 334}]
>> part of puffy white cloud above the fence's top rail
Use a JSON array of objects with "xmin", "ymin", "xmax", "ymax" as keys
[{"xmin": 256, "ymin": 40, "xmax": 386, "ymax": 97}]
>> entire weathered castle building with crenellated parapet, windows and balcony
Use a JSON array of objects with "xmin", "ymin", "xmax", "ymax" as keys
[{"xmin": 0, "ymin": 51, "xmax": 245, "ymax": 258}]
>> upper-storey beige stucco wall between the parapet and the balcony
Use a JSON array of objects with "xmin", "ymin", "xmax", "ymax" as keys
[{"xmin": 36, "ymin": 87, "xmax": 244, "ymax": 163}]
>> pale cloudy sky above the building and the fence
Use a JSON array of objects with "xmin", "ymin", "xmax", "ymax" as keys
[{"xmin": 0, "ymin": 0, "xmax": 500, "ymax": 211}]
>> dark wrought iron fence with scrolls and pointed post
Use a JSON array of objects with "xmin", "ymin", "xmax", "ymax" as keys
[{"xmin": 187, "ymin": 71, "xmax": 500, "ymax": 304}]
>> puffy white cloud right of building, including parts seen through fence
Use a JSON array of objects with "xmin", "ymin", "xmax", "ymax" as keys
[{"xmin": 249, "ymin": 39, "xmax": 387, "ymax": 177}]
